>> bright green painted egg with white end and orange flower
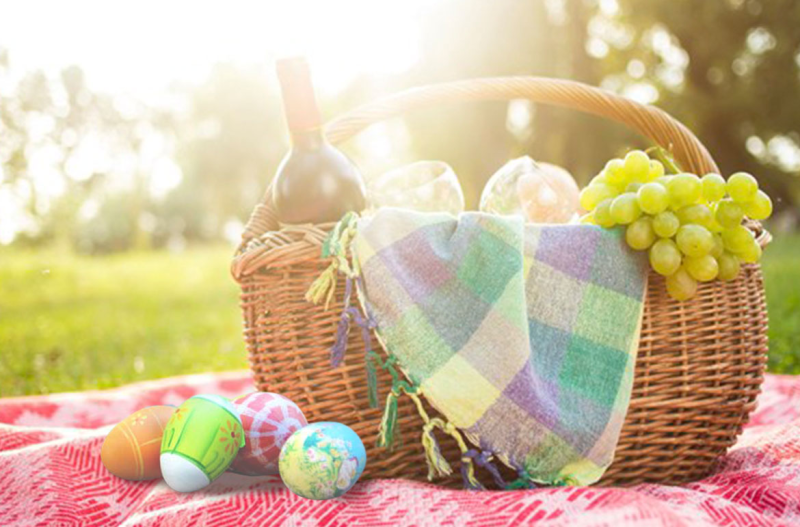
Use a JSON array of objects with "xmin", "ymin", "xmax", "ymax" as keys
[{"xmin": 161, "ymin": 395, "xmax": 244, "ymax": 492}]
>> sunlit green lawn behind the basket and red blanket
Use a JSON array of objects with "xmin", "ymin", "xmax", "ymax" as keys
[{"xmin": 0, "ymin": 236, "xmax": 800, "ymax": 396}]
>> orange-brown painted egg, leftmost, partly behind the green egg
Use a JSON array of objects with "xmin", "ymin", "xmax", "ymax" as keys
[{"xmin": 100, "ymin": 406, "xmax": 175, "ymax": 481}]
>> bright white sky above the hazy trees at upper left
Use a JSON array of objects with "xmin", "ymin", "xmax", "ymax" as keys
[{"xmin": 0, "ymin": 0, "xmax": 432, "ymax": 98}]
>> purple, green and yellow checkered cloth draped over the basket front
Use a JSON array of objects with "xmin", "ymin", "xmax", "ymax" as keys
[{"xmin": 353, "ymin": 209, "xmax": 646, "ymax": 485}]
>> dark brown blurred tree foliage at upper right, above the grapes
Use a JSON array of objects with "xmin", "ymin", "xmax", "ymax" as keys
[{"xmin": 600, "ymin": 0, "xmax": 800, "ymax": 207}]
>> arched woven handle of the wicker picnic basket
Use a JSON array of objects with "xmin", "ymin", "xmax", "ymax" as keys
[{"xmin": 242, "ymin": 77, "xmax": 719, "ymax": 246}]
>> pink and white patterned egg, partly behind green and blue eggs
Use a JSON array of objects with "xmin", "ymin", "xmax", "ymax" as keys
[{"xmin": 231, "ymin": 392, "xmax": 308, "ymax": 476}]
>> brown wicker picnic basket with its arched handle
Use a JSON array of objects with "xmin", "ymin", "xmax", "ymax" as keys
[{"xmin": 231, "ymin": 77, "xmax": 770, "ymax": 485}]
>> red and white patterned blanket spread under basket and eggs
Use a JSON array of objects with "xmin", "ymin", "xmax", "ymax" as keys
[{"xmin": 0, "ymin": 372, "xmax": 800, "ymax": 527}]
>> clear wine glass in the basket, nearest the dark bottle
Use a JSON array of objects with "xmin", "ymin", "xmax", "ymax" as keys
[{"xmin": 367, "ymin": 161, "xmax": 464, "ymax": 216}]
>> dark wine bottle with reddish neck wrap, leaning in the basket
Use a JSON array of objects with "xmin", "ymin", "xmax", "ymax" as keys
[{"xmin": 272, "ymin": 58, "xmax": 366, "ymax": 224}]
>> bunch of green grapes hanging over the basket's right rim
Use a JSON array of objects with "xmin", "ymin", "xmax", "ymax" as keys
[{"xmin": 580, "ymin": 150, "xmax": 772, "ymax": 300}]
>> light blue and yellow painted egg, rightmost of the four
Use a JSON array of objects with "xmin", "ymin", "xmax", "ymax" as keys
[{"xmin": 278, "ymin": 423, "xmax": 367, "ymax": 500}]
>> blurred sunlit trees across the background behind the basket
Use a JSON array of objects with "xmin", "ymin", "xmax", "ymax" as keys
[{"xmin": 0, "ymin": 0, "xmax": 800, "ymax": 253}]
